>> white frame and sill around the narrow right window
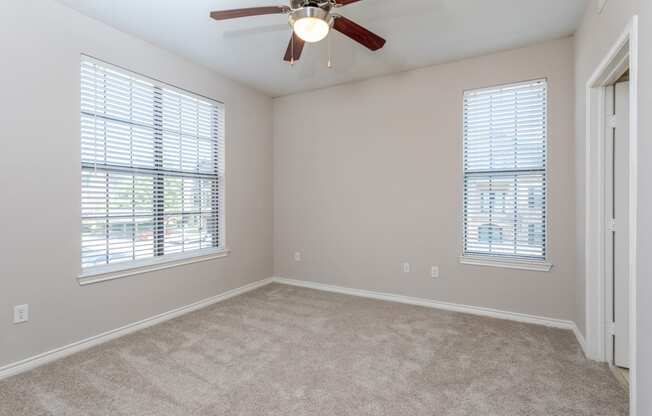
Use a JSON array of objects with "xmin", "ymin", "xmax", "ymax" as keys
[{"xmin": 459, "ymin": 77, "xmax": 553, "ymax": 272}]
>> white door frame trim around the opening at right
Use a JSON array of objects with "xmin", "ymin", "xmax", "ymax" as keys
[{"xmin": 584, "ymin": 16, "xmax": 638, "ymax": 416}]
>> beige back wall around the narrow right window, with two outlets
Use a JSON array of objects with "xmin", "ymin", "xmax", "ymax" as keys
[{"xmin": 274, "ymin": 38, "xmax": 577, "ymax": 320}]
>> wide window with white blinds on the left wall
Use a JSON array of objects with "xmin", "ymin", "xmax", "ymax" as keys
[{"xmin": 81, "ymin": 57, "xmax": 224, "ymax": 275}]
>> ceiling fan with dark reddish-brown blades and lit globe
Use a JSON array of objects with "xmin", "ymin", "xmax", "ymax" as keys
[{"xmin": 211, "ymin": 0, "xmax": 385, "ymax": 63}]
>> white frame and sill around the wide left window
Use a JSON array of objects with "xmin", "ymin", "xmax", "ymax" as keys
[{"xmin": 77, "ymin": 54, "xmax": 231, "ymax": 285}]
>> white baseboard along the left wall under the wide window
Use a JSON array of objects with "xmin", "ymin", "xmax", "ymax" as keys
[{"xmin": 0, "ymin": 278, "xmax": 273, "ymax": 380}]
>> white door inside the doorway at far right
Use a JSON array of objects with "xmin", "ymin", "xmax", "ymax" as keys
[{"xmin": 606, "ymin": 82, "xmax": 629, "ymax": 368}]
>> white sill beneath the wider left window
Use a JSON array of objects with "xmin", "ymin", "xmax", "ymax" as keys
[{"xmin": 78, "ymin": 248, "xmax": 231, "ymax": 286}]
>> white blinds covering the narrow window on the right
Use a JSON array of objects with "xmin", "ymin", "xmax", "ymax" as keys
[{"xmin": 464, "ymin": 80, "xmax": 547, "ymax": 261}]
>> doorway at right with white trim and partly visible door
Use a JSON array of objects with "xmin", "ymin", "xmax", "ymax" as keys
[{"xmin": 582, "ymin": 16, "xmax": 639, "ymax": 416}]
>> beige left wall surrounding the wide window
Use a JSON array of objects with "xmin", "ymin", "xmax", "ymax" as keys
[{"xmin": 0, "ymin": 0, "xmax": 272, "ymax": 367}]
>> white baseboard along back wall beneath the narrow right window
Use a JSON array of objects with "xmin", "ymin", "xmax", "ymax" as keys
[{"xmin": 272, "ymin": 277, "xmax": 586, "ymax": 355}]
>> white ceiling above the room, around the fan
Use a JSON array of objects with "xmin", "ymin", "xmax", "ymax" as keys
[{"xmin": 59, "ymin": 0, "xmax": 587, "ymax": 97}]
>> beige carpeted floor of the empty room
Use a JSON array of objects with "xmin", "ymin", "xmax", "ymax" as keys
[{"xmin": 0, "ymin": 285, "xmax": 628, "ymax": 416}]
